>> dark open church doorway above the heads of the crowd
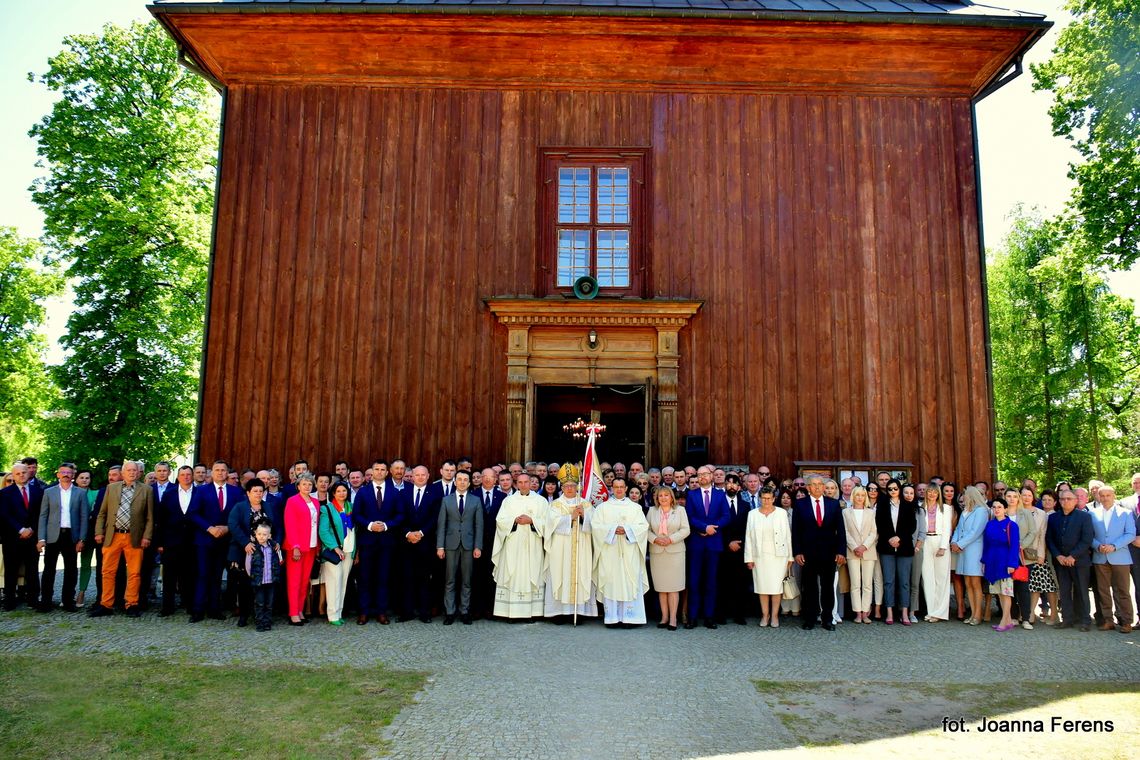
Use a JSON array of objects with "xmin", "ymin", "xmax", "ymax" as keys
[{"xmin": 534, "ymin": 385, "xmax": 645, "ymax": 466}]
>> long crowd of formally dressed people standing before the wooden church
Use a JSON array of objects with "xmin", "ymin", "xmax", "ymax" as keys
[{"xmin": 0, "ymin": 457, "xmax": 1140, "ymax": 634}]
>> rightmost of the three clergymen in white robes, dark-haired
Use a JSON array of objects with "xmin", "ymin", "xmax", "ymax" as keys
[{"xmin": 593, "ymin": 477, "xmax": 649, "ymax": 628}]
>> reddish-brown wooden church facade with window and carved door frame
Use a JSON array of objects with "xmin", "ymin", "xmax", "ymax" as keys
[{"xmin": 152, "ymin": 0, "xmax": 1048, "ymax": 479}]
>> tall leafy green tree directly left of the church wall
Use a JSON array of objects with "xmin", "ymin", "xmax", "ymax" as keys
[{"xmin": 30, "ymin": 22, "xmax": 218, "ymax": 464}]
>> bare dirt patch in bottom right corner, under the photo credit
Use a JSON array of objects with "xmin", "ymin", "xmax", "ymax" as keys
[{"xmin": 732, "ymin": 681, "xmax": 1140, "ymax": 760}]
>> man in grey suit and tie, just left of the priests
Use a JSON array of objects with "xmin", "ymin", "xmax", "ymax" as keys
[{"xmin": 435, "ymin": 469, "xmax": 483, "ymax": 626}]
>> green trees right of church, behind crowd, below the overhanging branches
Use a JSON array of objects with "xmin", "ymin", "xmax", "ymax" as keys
[{"xmin": 988, "ymin": 216, "xmax": 1140, "ymax": 483}]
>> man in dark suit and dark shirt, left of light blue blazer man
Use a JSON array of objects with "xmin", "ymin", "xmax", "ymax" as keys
[{"xmin": 1045, "ymin": 490, "xmax": 1094, "ymax": 631}]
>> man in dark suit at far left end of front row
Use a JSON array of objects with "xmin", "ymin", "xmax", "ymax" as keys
[{"xmin": 0, "ymin": 461, "xmax": 43, "ymax": 610}]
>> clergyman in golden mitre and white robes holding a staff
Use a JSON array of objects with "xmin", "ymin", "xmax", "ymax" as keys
[{"xmin": 544, "ymin": 471, "xmax": 597, "ymax": 618}]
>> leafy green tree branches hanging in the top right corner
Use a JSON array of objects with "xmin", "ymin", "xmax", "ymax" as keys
[{"xmin": 1032, "ymin": 0, "xmax": 1140, "ymax": 269}]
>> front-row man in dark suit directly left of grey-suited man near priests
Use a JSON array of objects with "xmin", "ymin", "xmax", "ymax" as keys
[{"xmin": 397, "ymin": 465, "xmax": 443, "ymax": 623}]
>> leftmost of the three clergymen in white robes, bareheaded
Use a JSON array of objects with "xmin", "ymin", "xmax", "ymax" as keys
[{"xmin": 491, "ymin": 473, "xmax": 547, "ymax": 620}]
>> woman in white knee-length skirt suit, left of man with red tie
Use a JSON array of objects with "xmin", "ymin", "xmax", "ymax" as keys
[{"xmin": 744, "ymin": 488, "xmax": 792, "ymax": 628}]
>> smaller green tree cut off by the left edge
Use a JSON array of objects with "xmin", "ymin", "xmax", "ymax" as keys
[{"xmin": 0, "ymin": 227, "xmax": 63, "ymax": 469}]
